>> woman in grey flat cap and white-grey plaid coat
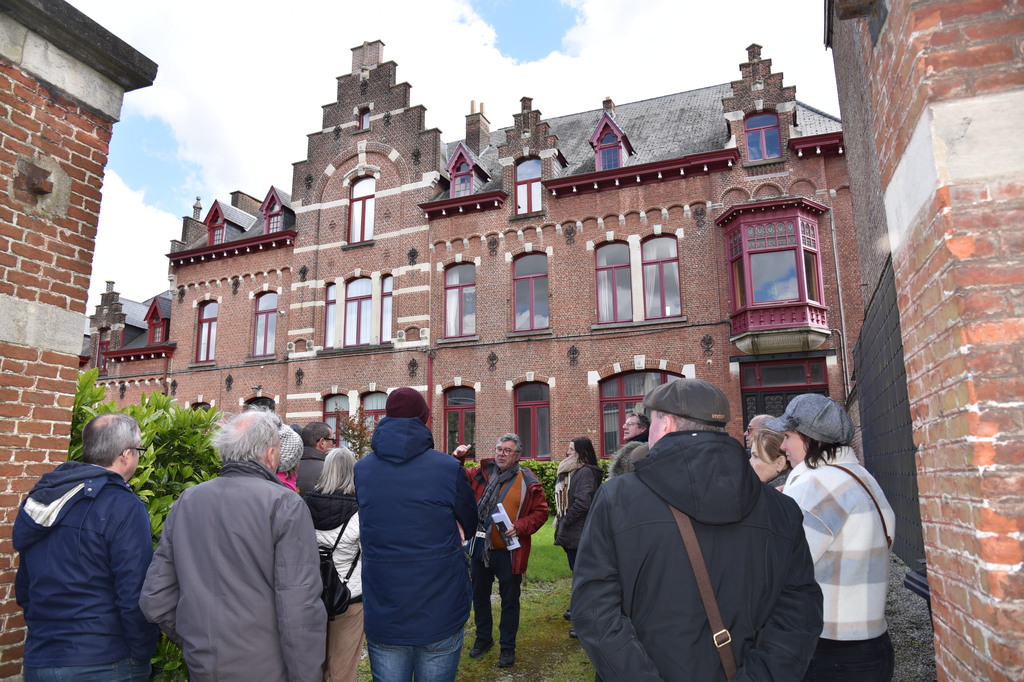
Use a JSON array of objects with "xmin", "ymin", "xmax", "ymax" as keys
[{"xmin": 764, "ymin": 393, "xmax": 896, "ymax": 682}]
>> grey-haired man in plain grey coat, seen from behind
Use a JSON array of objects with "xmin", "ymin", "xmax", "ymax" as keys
[{"xmin": 141, "ymin": 409, "xmax": 327, "ymax": 682}]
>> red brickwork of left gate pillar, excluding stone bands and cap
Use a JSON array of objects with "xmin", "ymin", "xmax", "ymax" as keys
[{"xmin": 0, "ymin": 59, "xmax": 113, "ymax": 678}]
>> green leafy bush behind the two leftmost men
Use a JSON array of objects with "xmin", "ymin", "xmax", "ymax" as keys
[{"xmin": 68, "ymin": 370, "xmax": 220, "ymax": 680}]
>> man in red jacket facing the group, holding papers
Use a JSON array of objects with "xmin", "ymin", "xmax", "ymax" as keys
[{"xmin": 455, "ymin": 433, "xmax": 548, "ymax": 668}]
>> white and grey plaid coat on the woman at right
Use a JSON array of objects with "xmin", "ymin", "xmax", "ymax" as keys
[{"xmin": 782, "ymin": 446, "xmax": 896, "ymax": 640}]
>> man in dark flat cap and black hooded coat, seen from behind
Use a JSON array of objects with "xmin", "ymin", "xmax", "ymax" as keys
[{"xmin": 571, "ymin": 379, "xmax": 822, "ymax": 681}]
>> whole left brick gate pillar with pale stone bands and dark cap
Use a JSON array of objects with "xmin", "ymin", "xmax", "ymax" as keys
[{"xmin": 0, "ymin": 0, "xmax": 157, "ymax": 667}]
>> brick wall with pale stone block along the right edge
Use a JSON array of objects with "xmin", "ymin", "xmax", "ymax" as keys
[{"xmin": 825, "ymin": 0, "xmax": 1024, "ymax": 680}]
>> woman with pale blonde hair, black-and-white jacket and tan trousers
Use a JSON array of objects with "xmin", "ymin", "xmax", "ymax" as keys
[{"xmin": 305, "ymin": 446, "xmax": 365, "ymax": 682}]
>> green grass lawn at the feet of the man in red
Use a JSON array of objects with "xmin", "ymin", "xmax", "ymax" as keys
[{"xmin": 358, "ymin": 519, "xmax": 594, "ymax": 682}]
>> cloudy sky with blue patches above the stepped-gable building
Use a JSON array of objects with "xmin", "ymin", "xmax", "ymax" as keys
[{"xmin": 68, "ymin": 0, "xmax": 840, "ymax": 312}]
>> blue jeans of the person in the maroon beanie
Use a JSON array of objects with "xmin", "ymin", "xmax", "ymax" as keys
[{"xmin": 367, "ymin": 630, "xmax": 462, "ymax": 682}]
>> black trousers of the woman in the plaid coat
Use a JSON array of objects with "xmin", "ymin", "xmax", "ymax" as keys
[{"xmin": 804, "ymin": 632, "xmax": 894, "ymax": 682}]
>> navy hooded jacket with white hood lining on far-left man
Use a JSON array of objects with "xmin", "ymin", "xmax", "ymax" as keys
[{"xmin": 12, "ymin": 462, "xmax": 160, "ymax": 668}]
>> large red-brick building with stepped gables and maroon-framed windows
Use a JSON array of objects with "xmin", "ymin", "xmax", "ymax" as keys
[{"xmin": 86, "ymin": 42, "xmax": 862, "ymax": 458}]
